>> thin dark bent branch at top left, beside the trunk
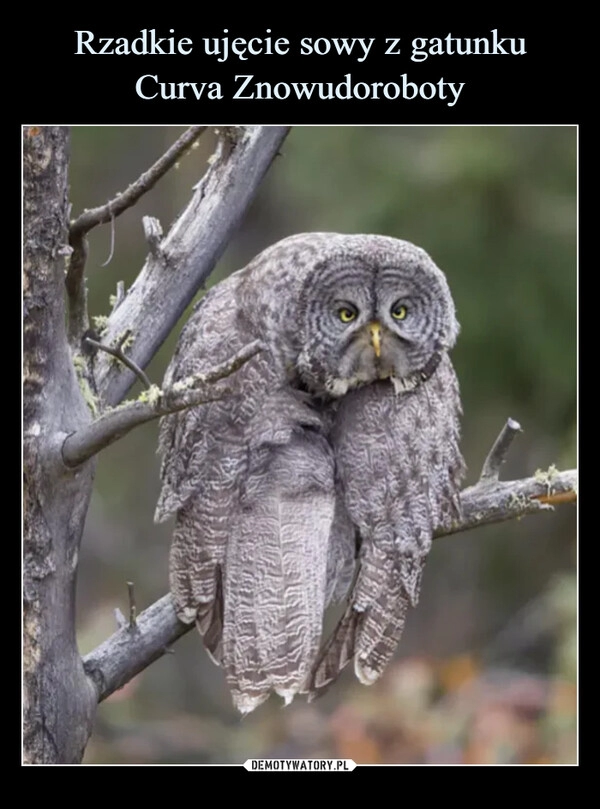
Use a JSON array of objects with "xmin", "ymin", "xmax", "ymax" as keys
[{"xmin": 65, "ymin": 126, "xmax": 206, "ymax": 344}]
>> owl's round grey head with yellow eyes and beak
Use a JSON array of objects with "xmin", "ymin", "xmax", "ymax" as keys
[{"xmin": 288, "ymin": 233, "xmax": 459, "ymax": 396}]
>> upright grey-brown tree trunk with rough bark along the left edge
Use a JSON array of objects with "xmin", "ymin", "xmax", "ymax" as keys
[{"xmin": 23, "ymin": 127, "xmax": 97, "ymax": 764}]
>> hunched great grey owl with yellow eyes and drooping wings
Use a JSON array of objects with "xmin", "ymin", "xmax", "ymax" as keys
[{"xmin": 156, "ymin": 233, "xmax": 463, "ymax": 713}]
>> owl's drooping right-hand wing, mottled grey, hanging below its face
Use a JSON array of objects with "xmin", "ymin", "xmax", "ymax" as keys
[{"xmin": 310, "ymin": 356, "xmax": 464, "ymax": 694}]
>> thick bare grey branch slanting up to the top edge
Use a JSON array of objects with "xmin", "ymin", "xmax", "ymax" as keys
[{"xmin": 96, "ymin": 126, "xmax": 289, "ymax": 406}]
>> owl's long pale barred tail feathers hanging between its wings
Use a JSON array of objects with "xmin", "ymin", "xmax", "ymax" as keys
[{"xmin": 220, "ymin": 487, "xmax": 333, "ymax": 713}]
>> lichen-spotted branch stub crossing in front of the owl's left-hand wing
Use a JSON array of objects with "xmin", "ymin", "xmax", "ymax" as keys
[{"xmin": 62, "ymin": 340, "xmax": 263, "ymax": 469}]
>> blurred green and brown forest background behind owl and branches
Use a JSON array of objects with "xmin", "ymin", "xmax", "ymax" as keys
[{"xmin": 70, "ymin": 126, "xmax": 577, "ymax": 764}]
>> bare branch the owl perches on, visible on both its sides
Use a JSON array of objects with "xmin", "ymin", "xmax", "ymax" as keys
[{"xmin": 83, "ymin": 469, "xmax": 577, "ymax": 702}]
